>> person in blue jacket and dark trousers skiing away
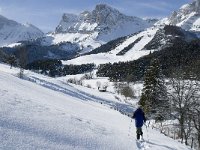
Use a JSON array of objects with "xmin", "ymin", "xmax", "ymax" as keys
[{"xmin": 132, "ymin": 106, "xmax": 146, "ymax": 140}]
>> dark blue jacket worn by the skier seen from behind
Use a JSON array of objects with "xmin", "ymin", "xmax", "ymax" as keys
[{"xmin": 132, "ymin": 108, "xmax": 146, "ymax": 128}]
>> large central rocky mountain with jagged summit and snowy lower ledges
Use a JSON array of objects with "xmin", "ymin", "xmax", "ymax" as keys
[{"xmin": 43, "ymin": 4, "xmax": 156, "ymax": 53}]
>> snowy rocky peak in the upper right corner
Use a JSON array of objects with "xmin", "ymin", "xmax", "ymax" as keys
[{"xmin": 157, "ymin": 0, "xmax": 200, "ymax": 32}]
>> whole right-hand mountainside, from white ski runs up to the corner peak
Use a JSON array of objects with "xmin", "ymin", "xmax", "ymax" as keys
[{"xmin": 63, "ymin": 0, "xmax": 200, "ymax": 65}]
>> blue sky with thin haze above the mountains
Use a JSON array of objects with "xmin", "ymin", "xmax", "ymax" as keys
[{"xmin": 0, "ymin": 0, "xmax": 192, "ymax": 32}]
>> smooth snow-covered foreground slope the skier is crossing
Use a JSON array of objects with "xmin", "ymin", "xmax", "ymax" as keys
[{"xmin": 0, "ymin": 64, "xmax": 189, "ymax": 150}]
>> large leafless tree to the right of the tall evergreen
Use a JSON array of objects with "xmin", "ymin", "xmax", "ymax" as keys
[{"xmin": 168, "ymin": 78, "xmax": 200, "ymax": 145}]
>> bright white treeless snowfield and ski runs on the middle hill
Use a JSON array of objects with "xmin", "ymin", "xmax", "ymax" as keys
[{"xmin": 63, "ymin": 27, "xmax": 158, "ymax": 65}]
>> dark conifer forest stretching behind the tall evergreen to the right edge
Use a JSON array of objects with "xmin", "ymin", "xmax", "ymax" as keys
[{"xmin": 97, "ymin": 39, "xmax": 200, "ymax": 81}]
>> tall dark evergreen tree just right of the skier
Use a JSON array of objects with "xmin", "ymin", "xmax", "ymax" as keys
[{"xmin": 139, "ymin": 59, "xmax": 169, "ymax": 120}]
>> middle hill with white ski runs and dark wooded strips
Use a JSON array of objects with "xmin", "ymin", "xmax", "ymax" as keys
[{"xmin": 63, "ymin": 25, "xmax": 197, "ymax": 65}]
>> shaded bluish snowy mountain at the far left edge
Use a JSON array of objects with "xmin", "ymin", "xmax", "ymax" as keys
[{"xmin": 0, "ymin": 15, "xmax": 44, "ymax": 46}]
